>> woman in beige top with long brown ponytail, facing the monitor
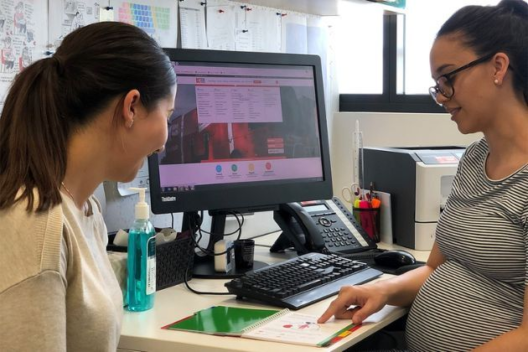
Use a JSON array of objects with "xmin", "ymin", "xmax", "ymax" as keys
[{"xmin": 0, "ymin": 22, "xmax": 176, "ymax": 351}]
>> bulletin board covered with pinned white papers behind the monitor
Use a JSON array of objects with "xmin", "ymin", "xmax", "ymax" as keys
[{"xmin": 0, "ymin": 0, "xmax": 328, "ymax": 231}]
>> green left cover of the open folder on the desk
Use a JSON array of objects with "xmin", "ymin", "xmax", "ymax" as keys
[{"xmin": 163, "ymin": 306, "xmax": 281, "ymax": 336}]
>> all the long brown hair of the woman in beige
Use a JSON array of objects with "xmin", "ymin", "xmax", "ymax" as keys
[{"xmin": 0, "ymin": 22, "xmax": 176, "ymax": 212}]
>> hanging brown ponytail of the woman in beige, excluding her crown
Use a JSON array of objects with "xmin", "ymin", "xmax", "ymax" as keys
[{"xmin": 0, "ymin": 59, "xmax": 67, "ymax": 210}]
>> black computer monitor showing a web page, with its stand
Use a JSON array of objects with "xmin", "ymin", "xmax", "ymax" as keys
[{"xmin": 149, "ymin": 49, "xmax": 332, "ymax": 278}]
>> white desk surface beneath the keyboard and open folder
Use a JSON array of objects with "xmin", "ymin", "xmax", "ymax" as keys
[{"xmin": 119, "ymin": 236, "xmax": 428, "ymax": 352}]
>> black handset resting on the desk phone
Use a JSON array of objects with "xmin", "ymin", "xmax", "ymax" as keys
[{"xmin": 271, "ymin": 203, "xmax": 327, "ymax": 254}]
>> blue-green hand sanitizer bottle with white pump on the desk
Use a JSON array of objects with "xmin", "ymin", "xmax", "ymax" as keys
[{"xmin": 127, "ymin": 188, "xmax": 156, "ymax": 312}]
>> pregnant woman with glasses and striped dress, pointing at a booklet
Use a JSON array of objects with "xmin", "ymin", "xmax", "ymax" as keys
[{"xmin": 319, "ymin": 0, "xmax": 528, "ymax": 351}]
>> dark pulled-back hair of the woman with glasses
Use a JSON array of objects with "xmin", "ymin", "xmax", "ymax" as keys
[{"xmin": 437, "ymin": 0, "xmax": 528, "ymax": 104}]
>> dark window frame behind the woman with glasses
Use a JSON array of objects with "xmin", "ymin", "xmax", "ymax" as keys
[{"xmin": 339, "ymin": 13, "xmax": 445, "ymax": 113}]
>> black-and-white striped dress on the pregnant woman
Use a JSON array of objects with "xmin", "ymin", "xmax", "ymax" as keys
[{"xmin": 406, "ymin": 139, "xmax": 528, "ymax": 351}]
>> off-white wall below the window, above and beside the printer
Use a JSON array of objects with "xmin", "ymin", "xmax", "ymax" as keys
[{"xmin": 330, "ymin": 112, "xmax": 482, "ymax": 199}]
